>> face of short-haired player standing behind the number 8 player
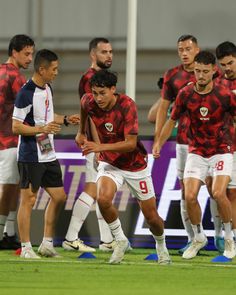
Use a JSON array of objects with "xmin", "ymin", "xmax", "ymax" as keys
[{"xmin": 178, "ymin": 40, "xmax": 199, "ymax": 66}]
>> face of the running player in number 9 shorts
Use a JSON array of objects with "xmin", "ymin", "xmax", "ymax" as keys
[{"xmin": 92, "ymin": 86, "xmax": 116, "ymax": 110}]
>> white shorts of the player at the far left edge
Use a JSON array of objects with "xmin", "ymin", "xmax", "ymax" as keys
[{"xmin": 0, "ymin": 148, "xmax": 20, "ymax": 184}]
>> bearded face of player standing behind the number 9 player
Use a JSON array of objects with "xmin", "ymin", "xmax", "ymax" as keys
[{"xmin": 94, "ymin": 42, "xmax": 113, "ymax": 69}]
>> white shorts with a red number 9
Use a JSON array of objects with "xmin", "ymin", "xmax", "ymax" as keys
[{"xmin": 97, "ymin": 162, "xmax": 155, "ymax": 201}]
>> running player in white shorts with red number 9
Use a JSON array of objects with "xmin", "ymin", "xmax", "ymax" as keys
[{"xmin": 76, "ymin": 70, "xmax": 170, "ymax": 264}]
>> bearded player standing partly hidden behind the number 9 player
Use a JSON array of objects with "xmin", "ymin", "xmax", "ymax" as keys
[{"xmin": 62, "ymin": 37, "xmax": 114, "ymax": 252}]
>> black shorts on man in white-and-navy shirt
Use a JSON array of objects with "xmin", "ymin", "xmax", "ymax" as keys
[{"xmin": 18, "ymin": 160, "xmax": 63, "ymax": 192}]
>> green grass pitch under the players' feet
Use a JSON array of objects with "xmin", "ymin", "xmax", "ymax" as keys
[{"xmin": 0, "ymin": 248, "xmax": 236, "ymax": 295}]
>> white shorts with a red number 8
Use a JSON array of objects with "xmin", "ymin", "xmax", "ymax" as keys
[{"xmin": 184, "ymin": 153, "xmax": 233, "ymax": 183}]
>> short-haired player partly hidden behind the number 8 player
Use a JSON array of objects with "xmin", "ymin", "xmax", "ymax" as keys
[{"xmin": 155, "ymin": 35, "xmax": 224, "ymax": 254}]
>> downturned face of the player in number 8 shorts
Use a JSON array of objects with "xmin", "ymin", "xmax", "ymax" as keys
[{"xmin": 194, "ymin": 62, "xmax": 215, "ymax": 87}]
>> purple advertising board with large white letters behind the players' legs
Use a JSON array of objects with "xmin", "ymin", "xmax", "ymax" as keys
[{"xmin": 31, "ymin": 139, "xmax": 214, "ymax": 249}]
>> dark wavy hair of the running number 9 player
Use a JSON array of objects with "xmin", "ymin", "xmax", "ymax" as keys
[{"xmin": 90, "ymin": 70, "xmax": 117, "ymax": 88}]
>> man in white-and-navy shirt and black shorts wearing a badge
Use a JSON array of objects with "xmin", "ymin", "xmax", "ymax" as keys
[{"xmin": 12, "ymin": 49, "xmax": 79, "ymax": 259}]
